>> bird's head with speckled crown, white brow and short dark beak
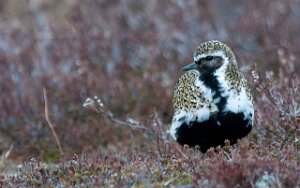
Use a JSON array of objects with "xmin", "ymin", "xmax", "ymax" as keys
[{"xmin": 181, "ymin": 40, "xmax": 236, "ymax": 73}]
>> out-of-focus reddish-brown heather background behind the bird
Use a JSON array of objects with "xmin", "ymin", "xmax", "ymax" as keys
[{"xmin": 0, "ymin": 0, "xmax": 300, "ymax": 160}]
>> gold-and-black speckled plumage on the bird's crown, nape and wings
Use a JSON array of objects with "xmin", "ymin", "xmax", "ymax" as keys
[{"xmin": 173, "ymin": 40, "xmax": 252, "ymax": 111}]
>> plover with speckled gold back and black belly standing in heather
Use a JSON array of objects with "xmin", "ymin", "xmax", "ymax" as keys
[{"xmin": 169, "ymin": 40, "xmax": 254, "ymax": 153}]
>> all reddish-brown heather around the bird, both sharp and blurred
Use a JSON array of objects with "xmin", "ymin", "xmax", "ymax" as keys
[{"xmin": 0, "ymin": 0, "xmax": 300, "ymax": 187}]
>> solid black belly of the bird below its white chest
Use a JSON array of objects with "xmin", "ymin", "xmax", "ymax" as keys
[{"xmin": 176, "ymin": 112, "xmax": 252, "ymax": 152}]
